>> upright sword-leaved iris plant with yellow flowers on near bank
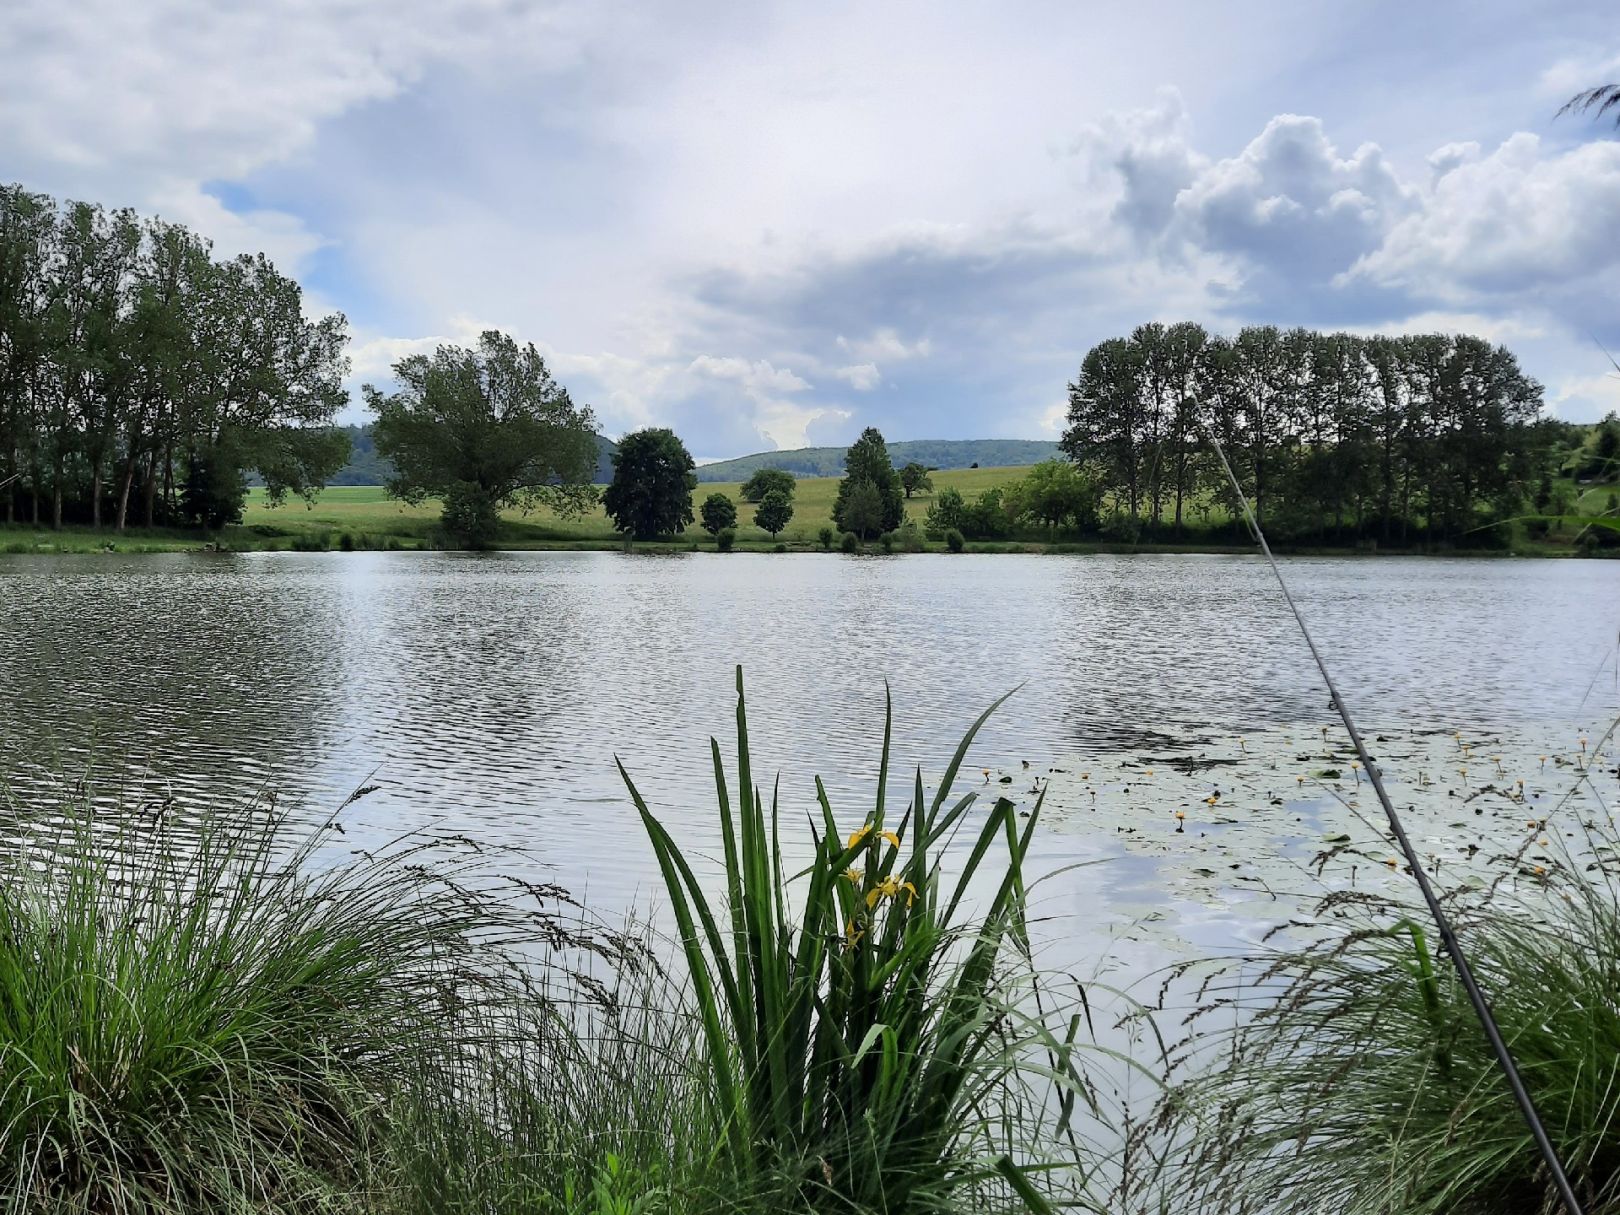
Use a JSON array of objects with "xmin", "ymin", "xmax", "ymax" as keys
[{"xmin": 620, "ymin": 669, "xmax": 1063, "ymax": 1215}]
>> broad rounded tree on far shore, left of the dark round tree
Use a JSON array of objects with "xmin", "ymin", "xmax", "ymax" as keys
[{"xmin": 363, "ymin": 330, "xmax": 602, "ymax": 548}]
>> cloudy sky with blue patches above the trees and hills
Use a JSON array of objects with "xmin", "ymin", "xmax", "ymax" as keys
[{"xmin": 0, "ymin": 0, "xmax": 1620, "ymax": 458}]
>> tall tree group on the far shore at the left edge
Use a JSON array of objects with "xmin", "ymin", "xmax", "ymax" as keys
[{"xmin": 0, "ymin": 185, "xmax": 348, "ymax": 530}]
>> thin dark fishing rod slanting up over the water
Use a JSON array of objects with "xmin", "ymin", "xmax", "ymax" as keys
[{"xmin": 1205, "ymin": 431, "xmax": 1583, "ymax": 1215}]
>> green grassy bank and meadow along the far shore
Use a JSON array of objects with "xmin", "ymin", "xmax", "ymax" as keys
[{"xmin": 0, "ymin": 467, "xmax": 1620, "ymax": 556}]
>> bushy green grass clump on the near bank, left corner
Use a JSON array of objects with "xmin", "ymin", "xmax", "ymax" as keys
[{"xmin": 0, "ymin": 793, "xmax": 638, "ymax": 1215}]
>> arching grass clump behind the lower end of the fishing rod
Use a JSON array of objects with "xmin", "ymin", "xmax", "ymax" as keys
[{"xmin": 1170, "ymin": 828, "xmax": 1620, "ymax": 1215}]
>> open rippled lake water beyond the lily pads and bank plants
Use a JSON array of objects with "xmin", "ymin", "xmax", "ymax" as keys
[{"xmin": 0, "ymin": 552, "xmax": 1620, "ymax": 902}]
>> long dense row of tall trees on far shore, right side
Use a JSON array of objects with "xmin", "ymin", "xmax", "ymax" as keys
[{"xmin": 1061, "ymin": 322, "xmax": 1549, "ymax": 543}]
